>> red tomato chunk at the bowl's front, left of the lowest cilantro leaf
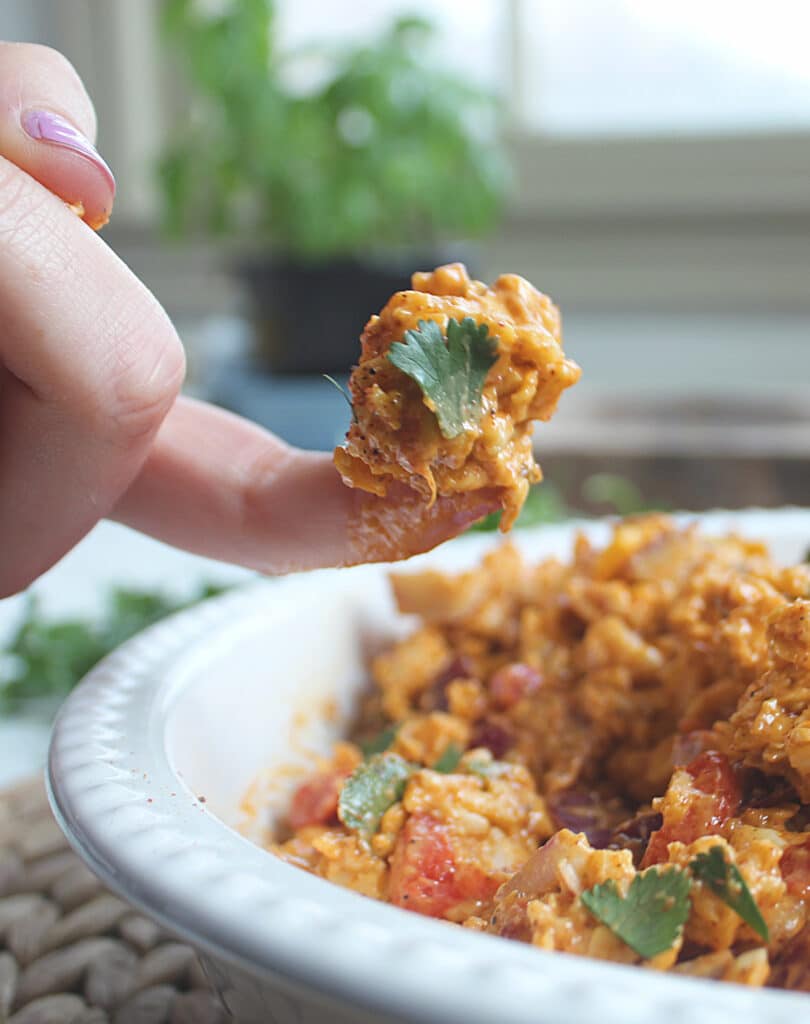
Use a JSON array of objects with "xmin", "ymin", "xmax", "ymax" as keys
[{"xmin": 389, "ymin": 814, "xmax": 503, "ymax": 918}]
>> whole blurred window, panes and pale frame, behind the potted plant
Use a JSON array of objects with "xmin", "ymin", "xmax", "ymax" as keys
[{"xmin": 0, "ymin": 0, "xmax": 810, "ymax": 312}]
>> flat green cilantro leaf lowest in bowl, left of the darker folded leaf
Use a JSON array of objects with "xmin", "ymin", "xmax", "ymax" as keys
[{"xmin": 580, "ymin": 867, "xmax": 691, "ymax": 959}]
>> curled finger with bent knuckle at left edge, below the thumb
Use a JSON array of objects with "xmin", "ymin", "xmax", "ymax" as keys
[{"xmin": 0, "ymin": 157, "xmax": 184, "ymax": 597}]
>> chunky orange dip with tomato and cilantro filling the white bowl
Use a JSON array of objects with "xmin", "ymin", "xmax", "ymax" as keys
[{"xmin": 273, "ymin": 516, "xmax": 810, "ymax": 990}]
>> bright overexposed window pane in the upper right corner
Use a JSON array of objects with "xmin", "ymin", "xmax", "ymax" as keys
[{"xmin": 516, "ymin": 0, "xmax": 810, "ymax": 137}]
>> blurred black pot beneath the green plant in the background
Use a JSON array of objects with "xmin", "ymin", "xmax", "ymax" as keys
[{"xmin": 239, "ymin": 246, "xmax": 474, "ymax": 374}]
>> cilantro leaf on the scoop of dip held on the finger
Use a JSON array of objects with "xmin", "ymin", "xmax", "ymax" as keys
[{"xmin": 388, "ymin": 316, "xmax": 498, "ymax": 438}]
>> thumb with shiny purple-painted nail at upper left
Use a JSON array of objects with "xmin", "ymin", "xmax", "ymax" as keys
[{"xmin": 0, "ymin": 43, "xmax": 116, "ymax": 228}]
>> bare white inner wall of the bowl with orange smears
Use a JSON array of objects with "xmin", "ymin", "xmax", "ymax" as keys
[{"xmin": 162, "ymin": 573, "xmax": 406, "ymax": 841}]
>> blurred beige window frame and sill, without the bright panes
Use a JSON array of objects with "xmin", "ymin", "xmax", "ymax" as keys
[{"xmin": 22, "ymin": 0, "xmax": 810, "ymax": 312}]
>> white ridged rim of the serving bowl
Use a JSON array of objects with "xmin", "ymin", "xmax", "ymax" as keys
[{"xmin": 46, "ymin": 509, "xmax": 810, "ymax": 1024}]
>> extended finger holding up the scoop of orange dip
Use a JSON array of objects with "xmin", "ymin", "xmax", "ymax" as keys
[{"xmin": 113, "ymin": 398, "xmax": 500, "ymax": 572}]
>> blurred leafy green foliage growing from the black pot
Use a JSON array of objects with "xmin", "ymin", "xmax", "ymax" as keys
[{"xmin": 159, "ymin": 0, "xmax": 509, "ymax": 261}]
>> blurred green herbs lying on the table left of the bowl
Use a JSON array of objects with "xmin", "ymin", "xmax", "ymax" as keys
[{"xmin": 0, "ymin": 585, "xmax": 223, "ymax": 714}]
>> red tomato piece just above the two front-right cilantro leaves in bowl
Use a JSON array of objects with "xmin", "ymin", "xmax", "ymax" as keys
[{"xmin": 641, "ymin": 751, "xmax": 740, "ymax": 867}]
